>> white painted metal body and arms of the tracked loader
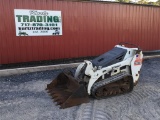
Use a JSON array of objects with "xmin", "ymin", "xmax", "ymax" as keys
[{"xmin": 75, "ymin": 45, "xmax": 143, "ymax": 95}]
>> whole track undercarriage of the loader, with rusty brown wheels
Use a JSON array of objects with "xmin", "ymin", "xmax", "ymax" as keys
[{"xmin": 92, "ymin": 72, "xmax": 133, "ymax": 99}]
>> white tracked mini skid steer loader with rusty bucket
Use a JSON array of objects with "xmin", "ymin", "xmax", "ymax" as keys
[{"xmin": 46, "ymin": 43, "xmax": 143, "ymax": 108}]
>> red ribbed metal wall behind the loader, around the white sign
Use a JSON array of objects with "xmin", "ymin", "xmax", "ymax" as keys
[{"xmin": 0, "ymin": 0, "xmax": 160, "ymax": 64}]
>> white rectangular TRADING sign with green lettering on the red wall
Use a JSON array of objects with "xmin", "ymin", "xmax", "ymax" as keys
[{"xmin": 14, "ymin": 9, "xmax": 62, "ymax": 36}]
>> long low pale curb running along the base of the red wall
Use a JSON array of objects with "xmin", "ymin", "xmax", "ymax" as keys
[{"xmin": 0, "ymin": 55, "xmax": 160, "ymax": 76}]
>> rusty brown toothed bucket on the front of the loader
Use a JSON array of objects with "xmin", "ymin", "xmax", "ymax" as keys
[{"xmin": 46, "ymin": 72, "xmax": 89, "ymax": 108}]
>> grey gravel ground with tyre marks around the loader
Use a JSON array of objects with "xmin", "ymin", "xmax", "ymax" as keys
[{"xmin": 0, "ymin": 58, "xmax": 160, "ymax": 120}]
